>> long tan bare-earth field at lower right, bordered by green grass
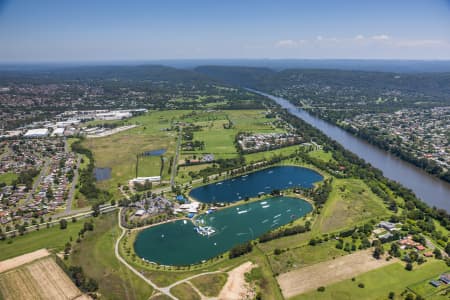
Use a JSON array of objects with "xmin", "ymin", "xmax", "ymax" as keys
[{"xmin": 277, "ymin": 250, "xmax": 397, "ymax": 298}]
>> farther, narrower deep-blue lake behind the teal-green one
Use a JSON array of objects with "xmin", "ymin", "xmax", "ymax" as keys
[{"xmin": 189, "ymin": 166, "xmax": 323, "ymax": 203}]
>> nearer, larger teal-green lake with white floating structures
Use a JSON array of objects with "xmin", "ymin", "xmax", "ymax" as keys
[{"xmin": 134, "ymin": 197, "xmax": 312, "ymax": 265}]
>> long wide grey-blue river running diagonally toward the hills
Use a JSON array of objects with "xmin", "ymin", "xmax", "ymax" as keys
[{"xmin": 252, "ymin": 90, "xmax": 450, "ymax": 211}]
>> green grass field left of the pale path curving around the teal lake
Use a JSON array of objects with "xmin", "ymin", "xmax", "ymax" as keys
[{"xmin": 70, "ymin": 213, "xmax": 153, "ymax": 299}]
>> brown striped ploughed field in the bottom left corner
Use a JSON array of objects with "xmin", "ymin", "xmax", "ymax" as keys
[{"xmin": 0, "ymin": 257, "xmax": 90, "ymax": 300}]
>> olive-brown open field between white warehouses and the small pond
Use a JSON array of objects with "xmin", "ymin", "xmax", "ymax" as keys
[{"xmin": 84, "ymin": 111, "xmax": 186, "ymax": 192}]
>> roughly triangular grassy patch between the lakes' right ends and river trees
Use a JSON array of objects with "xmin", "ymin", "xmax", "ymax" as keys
[{"xmin": 312, "ymin": 178, "xmax": 388, "ymax": 233}]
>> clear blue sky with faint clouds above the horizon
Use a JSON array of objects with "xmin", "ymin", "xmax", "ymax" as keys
[{"xmin": 0, "ymin": 0, "xmax": 450, "ymax": 62}]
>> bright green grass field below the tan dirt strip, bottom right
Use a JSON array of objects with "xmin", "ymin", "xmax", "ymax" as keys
[{"xmin": 291, "ymin": 259, "xmax": 449, "ymax": 300}]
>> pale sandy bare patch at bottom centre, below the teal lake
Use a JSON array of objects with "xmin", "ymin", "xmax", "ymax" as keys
[{"xmin": 219, "ymin": 261, "xmax": 255, "ymax": 300}]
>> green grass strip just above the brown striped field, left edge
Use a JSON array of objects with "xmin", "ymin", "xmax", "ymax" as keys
[{"xmin": 0, "ymin": 219, "xmax": 86, "ymax": 260}]
